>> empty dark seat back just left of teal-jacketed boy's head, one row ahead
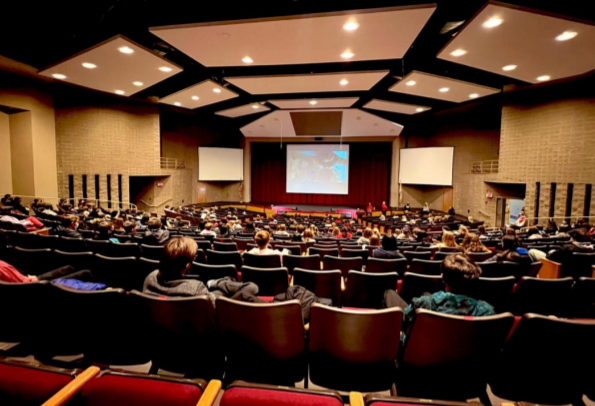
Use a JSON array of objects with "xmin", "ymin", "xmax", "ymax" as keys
[{"xmin": 343, "ymin": 271, "xmax": 399, "ymax": 309}]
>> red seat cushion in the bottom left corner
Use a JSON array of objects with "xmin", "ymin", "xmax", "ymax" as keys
[{"xmin": 0, "ymin": 363, "xmax": 73, "ymax": 406}]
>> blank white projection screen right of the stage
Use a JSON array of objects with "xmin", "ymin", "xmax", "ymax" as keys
[{"xmin": 399, "ymin": 147, "xmax": 455, "ymax": 186}]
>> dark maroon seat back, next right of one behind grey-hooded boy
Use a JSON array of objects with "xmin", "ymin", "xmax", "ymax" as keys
[{"xmin": 217, "ymin": 297, "xmax": 306, "ymax": 386}]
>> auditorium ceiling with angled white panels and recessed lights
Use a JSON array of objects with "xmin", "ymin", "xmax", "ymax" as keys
[{"xmin": 0, "ymin": 0, "xmax": 595, "ymax": 138}]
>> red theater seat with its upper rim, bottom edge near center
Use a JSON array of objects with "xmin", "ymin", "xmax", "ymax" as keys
[{"xmin": 220, "ymin": 381, "xmax": 344, "ymax": 406}]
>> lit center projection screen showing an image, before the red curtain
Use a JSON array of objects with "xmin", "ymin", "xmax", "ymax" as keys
[{"xmin": 286, "ymin": 144, "xmax": 349, "ymax": 195}]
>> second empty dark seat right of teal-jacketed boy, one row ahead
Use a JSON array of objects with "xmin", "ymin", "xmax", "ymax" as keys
[{"xmin": 511, "ymin": 276, "xmax": 574, "ymax": 317}]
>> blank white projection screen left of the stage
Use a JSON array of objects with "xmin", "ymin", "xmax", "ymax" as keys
[{"xmin": 198, "ymin": 148, "xmax": 244, "ymax": 182}]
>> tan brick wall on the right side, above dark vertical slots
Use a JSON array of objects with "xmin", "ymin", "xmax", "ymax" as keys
[{"xmin": 500, "ymin": 76, "xmax": 595, "ymax": 223}]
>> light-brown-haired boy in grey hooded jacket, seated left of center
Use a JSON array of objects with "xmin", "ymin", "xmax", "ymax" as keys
[{"xmin": 143, "ymin": 237, "xmax": 258, "ymax": 303}]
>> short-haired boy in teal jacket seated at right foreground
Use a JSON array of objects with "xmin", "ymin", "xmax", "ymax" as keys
[{"xmin": 384, "ymin": 254, "xmax": 496, "ymax": 332}]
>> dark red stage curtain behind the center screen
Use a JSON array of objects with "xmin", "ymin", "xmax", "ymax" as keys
[{"xmin": 252, "ymin": 143, "xmax": 392, "ymax": 209}]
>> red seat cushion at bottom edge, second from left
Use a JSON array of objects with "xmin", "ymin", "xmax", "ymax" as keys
[{"xmin": 82, "ymin": 375, "xmax": 202, "ymax": 406}]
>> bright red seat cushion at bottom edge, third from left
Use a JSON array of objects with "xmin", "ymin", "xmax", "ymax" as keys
[{"xmin": 220, "ymin": 388, "xmax": 343, "ymax": 406}]
